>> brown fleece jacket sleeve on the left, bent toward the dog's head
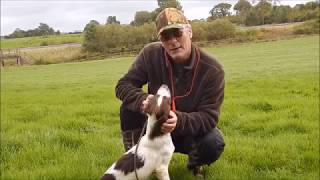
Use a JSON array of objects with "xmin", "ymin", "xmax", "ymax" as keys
[{"xmin": 115, "ymin": 50, "xmax": 148, "ymax": 111}]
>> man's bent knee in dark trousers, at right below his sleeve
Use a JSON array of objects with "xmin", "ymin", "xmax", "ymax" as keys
[{"xmin": 198, "ymin": 128, "xmax": 225, "ymax": 164}]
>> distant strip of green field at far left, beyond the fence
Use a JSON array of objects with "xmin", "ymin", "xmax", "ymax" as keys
[{"xmin": 1, "ymin": 34, "xmax": 82, "ymax": 49}]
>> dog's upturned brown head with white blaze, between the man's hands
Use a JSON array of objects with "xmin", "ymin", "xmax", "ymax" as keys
[{"xmin": 145, "ymin": 84, "xmax": 171, "ymax": 121}]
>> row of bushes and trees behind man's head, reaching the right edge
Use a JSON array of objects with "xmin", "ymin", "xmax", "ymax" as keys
[{"xmin": 82, "ymin": 0, "xmax": 319, "ymax": 53}]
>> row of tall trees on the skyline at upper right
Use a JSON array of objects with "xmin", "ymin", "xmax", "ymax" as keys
[{"xmin": 225, "ymin": 0, "xmax": 319, "ymax": 26}]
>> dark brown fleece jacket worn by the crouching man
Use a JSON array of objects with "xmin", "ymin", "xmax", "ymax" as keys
[{"xmin": 116, "ymin": 42, "xmax": 224, "ymax": 136}]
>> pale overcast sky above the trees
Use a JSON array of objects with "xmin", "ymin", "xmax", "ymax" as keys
[{"xmin": 1, "ymin": 0, "xmax": 314, "ymax": 35}]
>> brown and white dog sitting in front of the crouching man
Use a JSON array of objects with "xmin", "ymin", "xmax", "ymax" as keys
[{"xmin": 101, "ymin": 85, "xmax": 174, "ymax": 180}]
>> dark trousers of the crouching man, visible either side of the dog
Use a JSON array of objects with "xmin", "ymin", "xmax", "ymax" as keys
[{"xmin": 120, "ymin": 106, "xmax": 225, "ymax": 168}]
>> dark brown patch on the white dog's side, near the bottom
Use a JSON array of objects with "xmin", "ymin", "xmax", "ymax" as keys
[{"xmin": 114, "ymin": 152, "xmax": 144, "ymax": 175}]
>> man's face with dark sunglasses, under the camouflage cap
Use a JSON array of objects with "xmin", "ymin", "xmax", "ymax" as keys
[{"xmin": 160, "ymin": 27, "xmax": 192, "ymax": 64}]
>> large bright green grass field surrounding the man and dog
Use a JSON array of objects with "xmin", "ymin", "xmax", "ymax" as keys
[{"xmin": 0, "ymin": 36, "xmax": 319, "ymax": 180}]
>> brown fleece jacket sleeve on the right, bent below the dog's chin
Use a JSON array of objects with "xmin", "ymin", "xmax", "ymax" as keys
[{"xmin": 173, "ymin": 70, "xmax": 225, "ymax": 136}]
